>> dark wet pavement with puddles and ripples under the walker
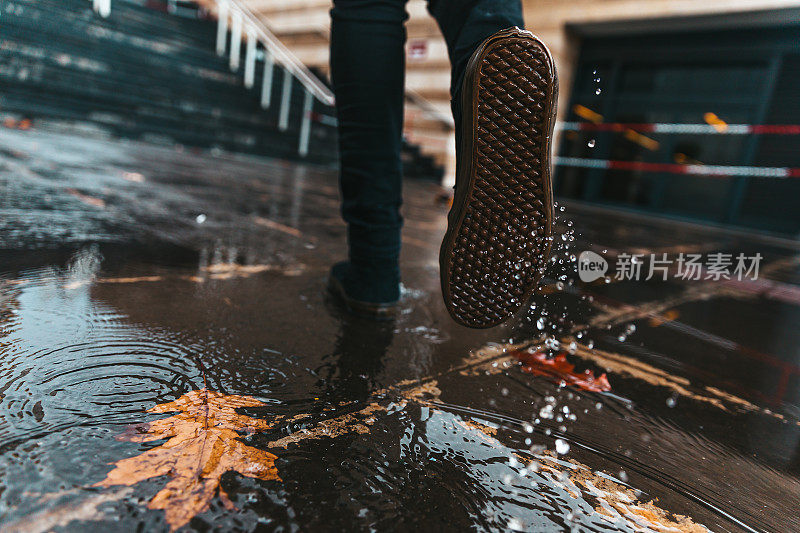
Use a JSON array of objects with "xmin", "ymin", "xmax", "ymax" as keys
[{"xmin": 0, "ymin": 129, "xmax": 800, "ymax": 532}]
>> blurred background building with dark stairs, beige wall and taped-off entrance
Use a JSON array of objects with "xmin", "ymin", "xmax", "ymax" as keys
[{"xmin": 0, "ymin": 0, "xmax": 800, "ymax": 238}]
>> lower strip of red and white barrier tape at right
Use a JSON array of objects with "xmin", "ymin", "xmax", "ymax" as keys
[{"xmin": 554, "ymin": 157, "xmax": 800, "ymax": 178}]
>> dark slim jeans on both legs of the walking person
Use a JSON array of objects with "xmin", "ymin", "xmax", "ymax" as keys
[{"xmin": 331, "ymin": 0, "xmax": 524, "ymax": 267}]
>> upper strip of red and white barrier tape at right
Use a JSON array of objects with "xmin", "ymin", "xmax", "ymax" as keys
[{"xmin": 556, "ymin": 122, "xmax": 800, "ymax": 135}]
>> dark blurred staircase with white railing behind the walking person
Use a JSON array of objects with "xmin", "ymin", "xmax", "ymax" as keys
[{"xmin": 0, "ymin": 0, "xmax": 441, "ymax": 181}]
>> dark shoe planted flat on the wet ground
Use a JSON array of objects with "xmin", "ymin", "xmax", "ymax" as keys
[{"xmin": 328, "ymin": 261, "xmax": 400, "ymax": 320}]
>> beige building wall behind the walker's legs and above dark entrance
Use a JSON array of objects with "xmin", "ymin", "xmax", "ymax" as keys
[{"xmin": 241, "ymin": 0, "xmax": 800, "ymax": 184}]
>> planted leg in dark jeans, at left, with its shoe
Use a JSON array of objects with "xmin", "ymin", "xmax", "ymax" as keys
[{"xmin": 330, "ymin": 0, "xmax": 408, "ymax": 310}]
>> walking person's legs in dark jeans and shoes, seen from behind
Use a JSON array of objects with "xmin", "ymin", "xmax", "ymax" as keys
[{"xmin": 329, "ymin": 0, "xmax": 558, "ymax": 328}]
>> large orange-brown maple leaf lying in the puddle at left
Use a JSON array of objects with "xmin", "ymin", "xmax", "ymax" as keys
[{"xmin": 95, "ymin": 389, "xmax": 281, "ymax": 531}]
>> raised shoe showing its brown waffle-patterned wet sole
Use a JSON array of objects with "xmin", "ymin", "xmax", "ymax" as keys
[{"xmin": 439, "ymin": 28, "xmax": 558, "ymax": 328}]
